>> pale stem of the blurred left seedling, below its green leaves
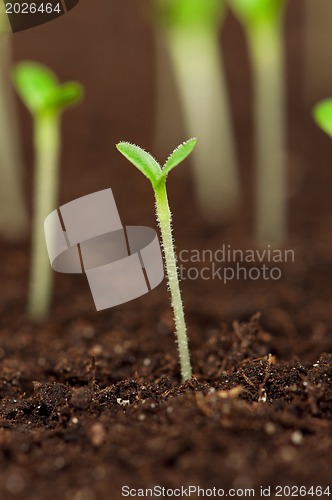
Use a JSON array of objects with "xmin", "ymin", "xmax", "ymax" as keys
[{"xmin": 28, "ymin": 114, "xmax": 60, "ymax": 319}]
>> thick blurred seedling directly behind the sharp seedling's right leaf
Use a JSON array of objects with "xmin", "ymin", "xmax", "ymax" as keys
[{"xmin": 150, "ymin": 0, "xmax": 239, "ymax": 222}]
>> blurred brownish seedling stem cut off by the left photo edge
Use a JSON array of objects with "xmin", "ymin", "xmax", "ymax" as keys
[{"xmin": 0, "ymin": 2, "xmax": 28, "ymax": 241}]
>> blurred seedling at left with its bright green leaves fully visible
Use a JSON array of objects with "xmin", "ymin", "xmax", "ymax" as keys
[{"xmin": 13, "ymin": 62, "xmax": 83, "ymax": 319}]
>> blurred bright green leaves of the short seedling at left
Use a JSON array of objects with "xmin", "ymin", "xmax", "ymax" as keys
[{"xmin": 13, "ymin": 62, "xmax": 83, "ymax": 115}]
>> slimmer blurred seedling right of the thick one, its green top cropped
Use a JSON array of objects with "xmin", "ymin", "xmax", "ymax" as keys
[{"xmin": 228, "ymin": 0, "xmax": 287, "ymax": 246}]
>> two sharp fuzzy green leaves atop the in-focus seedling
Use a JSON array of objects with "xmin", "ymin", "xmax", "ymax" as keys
[{"xmin": 116, "ymin": 138, "xmax": 197, "ymax": 189}]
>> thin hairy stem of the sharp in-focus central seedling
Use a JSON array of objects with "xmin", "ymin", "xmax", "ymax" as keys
[{"xmin": 155, "ymin": 180, "xmax": 192, "ymax": 382}]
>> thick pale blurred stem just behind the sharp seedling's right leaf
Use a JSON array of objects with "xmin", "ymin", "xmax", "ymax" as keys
[{"xmin": 167, "ymin": 28, "xmax": 239, "ymax": 221}]
